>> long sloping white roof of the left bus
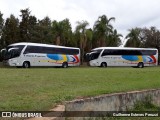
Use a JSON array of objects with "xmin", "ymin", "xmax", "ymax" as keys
[{"xmin": 9, "ymin": 42, "xmax": 79, "ymax": 49}]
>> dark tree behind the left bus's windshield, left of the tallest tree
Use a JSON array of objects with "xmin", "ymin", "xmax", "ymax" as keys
[{"xmin": 2, "ymin": 14, "xmax": 20, "ymax": 46}]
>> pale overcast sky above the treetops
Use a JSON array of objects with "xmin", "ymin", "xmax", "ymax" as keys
[{"xmin": 0, "ymin": 0, "xmax": 160, "ymax": 44}]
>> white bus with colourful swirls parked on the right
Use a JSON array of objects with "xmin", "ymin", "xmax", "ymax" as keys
[{"xmin": 86, "ymin": 47, "xmax": 158, "ymax": 68}]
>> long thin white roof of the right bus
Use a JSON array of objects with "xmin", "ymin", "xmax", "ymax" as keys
[{"xmin": 92, "ymin": 47, "xmax": 157, "ymax": 50}]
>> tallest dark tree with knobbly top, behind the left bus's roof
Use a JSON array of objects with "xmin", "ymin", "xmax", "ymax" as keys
[{"xmin": 20, "ymin": 8, "xmax": 44, "ymax": 43}]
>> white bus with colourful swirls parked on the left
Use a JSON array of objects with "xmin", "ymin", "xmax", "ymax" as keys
[{"xmin": 1, "ymin": 42, "xmax": 80, "ymax": 68}]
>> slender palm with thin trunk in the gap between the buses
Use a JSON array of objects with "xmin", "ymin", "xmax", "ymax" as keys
[{"xmin": 76, "ymin": 21, "xmax": 89, "ymax": 64}]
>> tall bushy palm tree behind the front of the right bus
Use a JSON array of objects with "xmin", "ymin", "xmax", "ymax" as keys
[{"xmin": 93, "ymin": 15, "xmax": 115, "ymax": 46}]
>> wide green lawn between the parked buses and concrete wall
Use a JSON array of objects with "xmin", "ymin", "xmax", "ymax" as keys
[{"xmin": 0, "ymin": 67, "xmax": 160, "ymax": 111}]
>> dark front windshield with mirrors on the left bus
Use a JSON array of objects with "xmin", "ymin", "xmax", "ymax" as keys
[{"xmin": 1, "ymin": 45, "xmax": 24, "ymax": 60}]
